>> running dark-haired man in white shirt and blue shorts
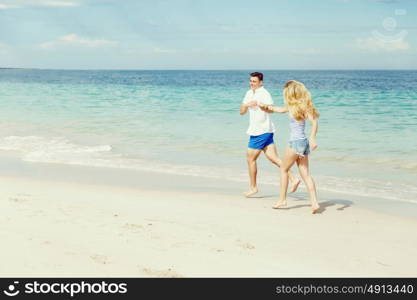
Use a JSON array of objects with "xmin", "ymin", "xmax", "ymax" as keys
[{"xmin": 240, "ymin": 72, "xmax": 300, "ymax": 197}]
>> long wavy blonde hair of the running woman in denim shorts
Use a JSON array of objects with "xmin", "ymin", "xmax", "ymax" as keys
[{"xmin": 283, "ymin": 80, "xmax": 320, "ymax": 121}]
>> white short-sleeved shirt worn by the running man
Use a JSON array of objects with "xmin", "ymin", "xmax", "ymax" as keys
[{"xmin": 243, "ymin": 86, "xmax": 275, "ymax": 135}]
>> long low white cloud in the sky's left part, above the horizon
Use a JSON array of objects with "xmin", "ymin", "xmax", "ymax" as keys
[{"xmin": 38, "ymin": 33, "xmax": 119, "ymax": 50}]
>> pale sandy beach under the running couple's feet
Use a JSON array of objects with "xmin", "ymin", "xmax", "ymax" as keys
[{"xmin": 0, "ymin": 155, "xmax": 417, "ymax": 277}]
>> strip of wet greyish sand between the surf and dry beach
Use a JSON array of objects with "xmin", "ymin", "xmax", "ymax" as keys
[{"xmin": 0, "ymin": 151, "xmax": 417, "ymax": 220}]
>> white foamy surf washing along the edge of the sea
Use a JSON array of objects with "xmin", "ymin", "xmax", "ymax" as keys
[{"xmin": 0, "ymin": 136, "xmax": 417, "ymax": 204}]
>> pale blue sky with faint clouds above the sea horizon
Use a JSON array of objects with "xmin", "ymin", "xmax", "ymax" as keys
[{"xmin": 0, "ymin": 0, "xmax": 417, "ymax": 69}]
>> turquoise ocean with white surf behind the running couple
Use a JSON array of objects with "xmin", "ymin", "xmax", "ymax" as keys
[{"xmin": 0, "ymin": 69, "xmax": 417, "ymax": 204}]
